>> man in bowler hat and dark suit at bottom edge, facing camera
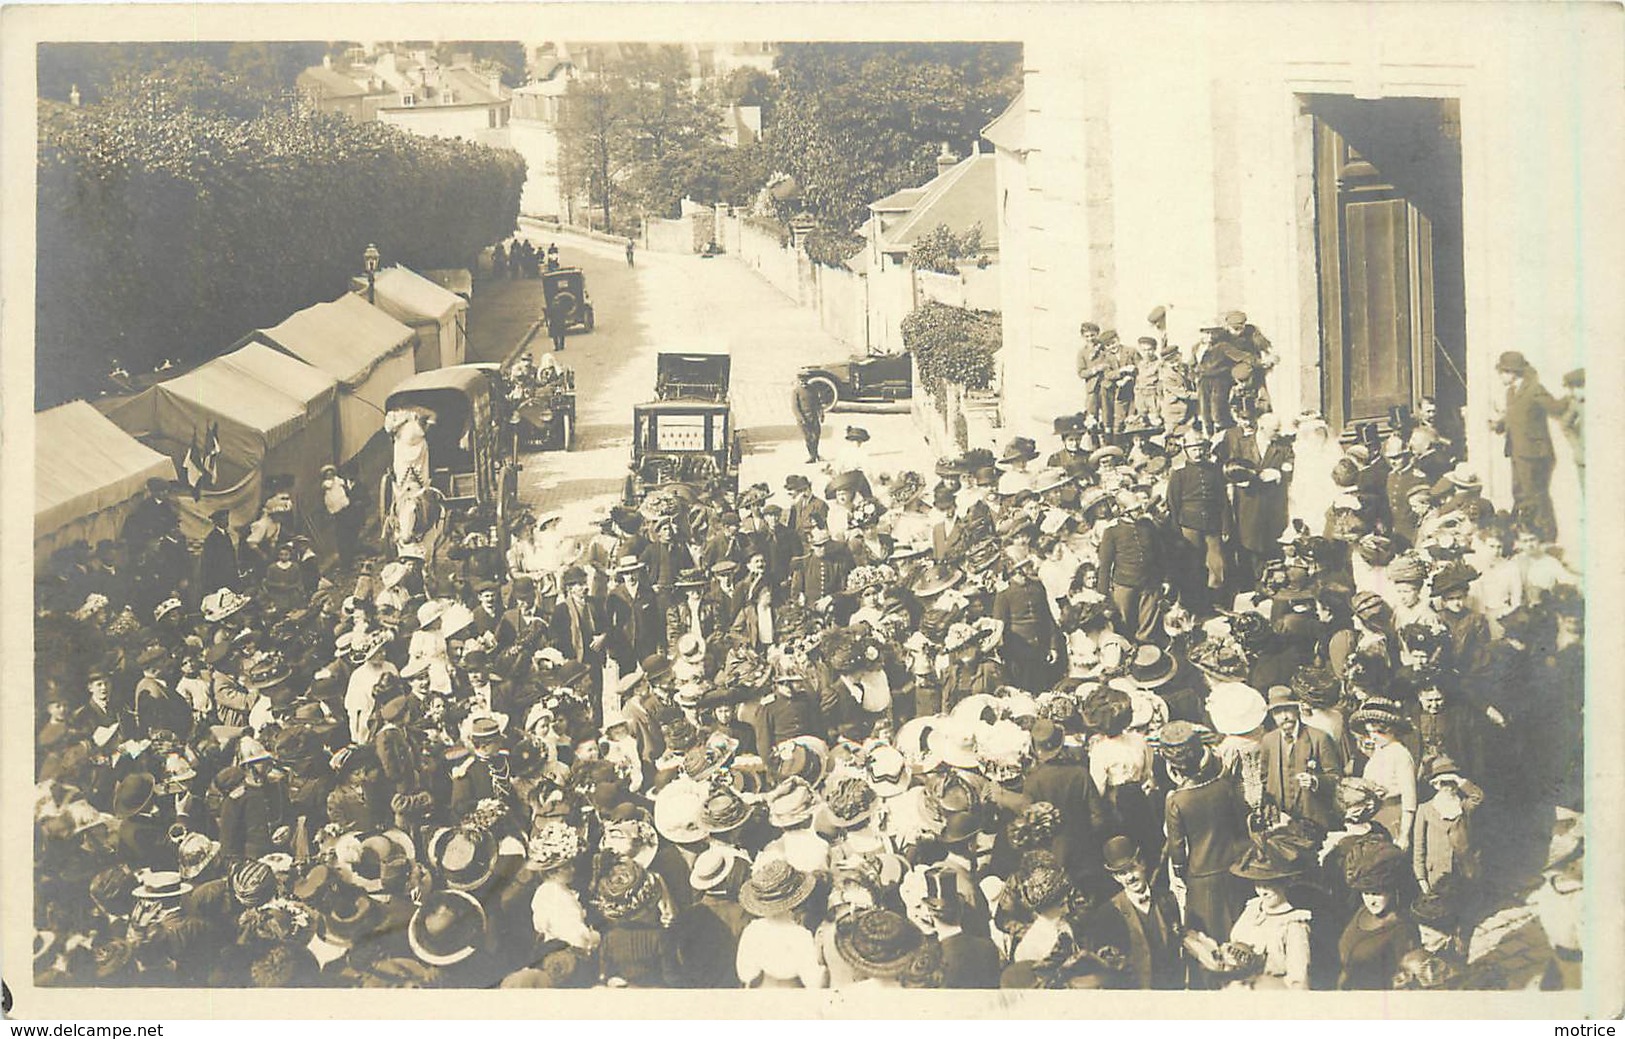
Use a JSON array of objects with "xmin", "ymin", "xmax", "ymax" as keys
[{"xmin": 1084, "ymin": 836, "xmax": 1185, "ymax": 989}]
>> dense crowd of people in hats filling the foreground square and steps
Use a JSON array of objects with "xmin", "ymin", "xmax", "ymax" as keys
[{"xmin": 34, "ymin": 319, "xmax": 1583, "ymax": 990}]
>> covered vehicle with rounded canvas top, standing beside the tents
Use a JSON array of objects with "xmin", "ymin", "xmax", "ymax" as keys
[{"xmin": 379, "ymin": 364, "xmax": 518, "ymax": 548}]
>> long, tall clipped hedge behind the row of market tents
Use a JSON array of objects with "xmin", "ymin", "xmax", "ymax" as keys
[{"xmin": 36, "ymin": 76, "xmax": 525, "ymax": 406}]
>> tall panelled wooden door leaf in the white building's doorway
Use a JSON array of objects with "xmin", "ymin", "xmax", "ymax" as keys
[{"xmin": 1315, "ymin": 119, "xmax": 1433, "ymax": 428}]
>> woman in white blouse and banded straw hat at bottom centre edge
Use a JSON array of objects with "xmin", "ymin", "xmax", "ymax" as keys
[{"xmin": 736, "ymin": 852, "xmax": 829, "ymax": 989}]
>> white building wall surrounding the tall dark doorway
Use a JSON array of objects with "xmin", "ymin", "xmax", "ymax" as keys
[{"xmin": 1001, "ymin": 5, "xmax": 1625, "ymax": 546}]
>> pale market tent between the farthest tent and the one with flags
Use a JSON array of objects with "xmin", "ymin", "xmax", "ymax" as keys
[{"xmin": 250, "ymin": 294, "xmax": 416, "ymax": 463}]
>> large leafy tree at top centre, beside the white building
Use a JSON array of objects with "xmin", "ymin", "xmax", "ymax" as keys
[{"xmin": 765, "ymin": 44, "xmax": 1021, "ymax": 231}]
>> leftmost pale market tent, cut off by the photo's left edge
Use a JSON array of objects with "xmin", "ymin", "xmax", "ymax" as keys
[{"xmin": 34, "ymin": 400, "xmax": 176, "ymax": 559}]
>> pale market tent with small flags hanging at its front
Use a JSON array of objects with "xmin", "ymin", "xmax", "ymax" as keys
[{"xmin": 106, "ymin": 343, "xmax": 338, "ymax": 537}]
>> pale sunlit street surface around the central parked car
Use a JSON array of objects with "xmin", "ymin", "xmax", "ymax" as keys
[{"xmin": 468, "ymin": 228, "xmax": 930, "ymax": 536}]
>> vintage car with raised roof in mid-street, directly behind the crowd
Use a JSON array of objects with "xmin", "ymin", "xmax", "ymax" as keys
[{"xmin": 622, "ymin": 351, "xmax": 744, "ymax": 504}]
